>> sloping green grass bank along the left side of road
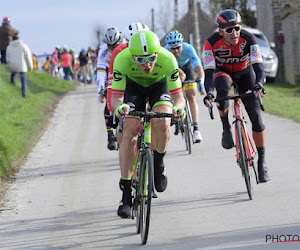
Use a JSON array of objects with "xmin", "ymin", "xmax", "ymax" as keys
[{"xmin": 0, "ymin": 65, "xmax": 75, "ymax": 186}]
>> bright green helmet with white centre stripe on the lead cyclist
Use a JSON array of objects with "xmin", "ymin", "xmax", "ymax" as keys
[{"xmin": 129, "ymin": 30, "xmax": 160, "ymax": 56}]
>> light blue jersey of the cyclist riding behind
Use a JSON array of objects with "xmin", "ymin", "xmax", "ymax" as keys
[{"xmin": 165, "ymin": 43, "xmax": 202, "ymax": 69}]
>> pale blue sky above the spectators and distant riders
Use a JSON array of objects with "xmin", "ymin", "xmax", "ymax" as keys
[{"xmin": 0, "ymin": 0, "xmax": 188, "ymax": 54}]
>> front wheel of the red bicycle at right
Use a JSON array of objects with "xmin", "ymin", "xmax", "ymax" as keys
[{"xmin": 236, "ymin": 120, "xmax": 253, "ymax": 200}]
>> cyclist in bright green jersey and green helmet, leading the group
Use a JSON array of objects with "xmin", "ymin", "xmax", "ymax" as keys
[{"xmin": 111, "ymin": 31, "xmax": 185, "ymax": 218}]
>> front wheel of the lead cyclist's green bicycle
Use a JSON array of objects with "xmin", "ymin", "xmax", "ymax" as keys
[{"xmin": 137, "ymin": 148, "xmax": 153, "ymax": 245}]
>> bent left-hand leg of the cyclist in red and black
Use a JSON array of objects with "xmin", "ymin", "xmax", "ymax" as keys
[{"xmin": 214, "ymin": 71, "xmax": 234, "ymax": 149}]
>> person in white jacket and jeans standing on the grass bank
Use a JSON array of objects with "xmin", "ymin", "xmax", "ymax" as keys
[{"xmin": 6, "ymin": 35, "xmax": 33, "ymax": 98}]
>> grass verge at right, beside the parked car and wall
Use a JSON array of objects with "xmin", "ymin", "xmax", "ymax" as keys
[{"xmin": 263, "ymin": 83, "xmax": 300, "ymax": 123}]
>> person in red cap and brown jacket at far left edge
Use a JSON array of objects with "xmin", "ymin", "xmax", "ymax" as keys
[{"xmin": 0, "ymin": 17, "xmax": 19, "ymax": 64}]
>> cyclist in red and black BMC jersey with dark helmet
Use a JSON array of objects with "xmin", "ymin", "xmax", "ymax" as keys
[{"xmin": 203, "ymin": 9, "xmax": 270, "ymax": 182}]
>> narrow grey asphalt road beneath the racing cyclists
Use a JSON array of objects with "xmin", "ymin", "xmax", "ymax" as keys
[{"xmin": 0, "ymin": 85, "xmax": 300, "ymax": 249}]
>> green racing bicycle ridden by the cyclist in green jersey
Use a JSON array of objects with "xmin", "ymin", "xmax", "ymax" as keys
[{"xmin": 118, "ymin": 109, "xmax": 173, "ymax": 245}]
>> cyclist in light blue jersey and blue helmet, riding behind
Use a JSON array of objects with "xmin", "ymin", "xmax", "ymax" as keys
[{"xmin": 165, "ymin": 30, "xmax": 205, "ymax": 143}]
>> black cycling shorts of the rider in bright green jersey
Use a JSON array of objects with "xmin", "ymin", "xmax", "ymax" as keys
[{"xmin": 124, "ymin": 77, "xmax": 173, "ymax": 111}]
